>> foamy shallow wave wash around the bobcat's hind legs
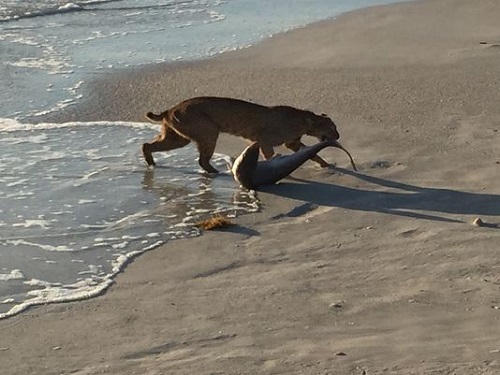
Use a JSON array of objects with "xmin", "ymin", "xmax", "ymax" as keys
[{"xmin": 0, "ymin": 119, "xmax": 258, "ymax": 318}]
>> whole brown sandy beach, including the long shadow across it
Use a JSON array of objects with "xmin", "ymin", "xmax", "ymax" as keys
[{"xmin": 0, "ymin": 0, "xmax": 500, "ymax": 375}]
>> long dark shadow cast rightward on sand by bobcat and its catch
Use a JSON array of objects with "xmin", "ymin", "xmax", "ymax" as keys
[{"xmin": 260, "ymin": 168, "xmax": 500, "ymax": 228}]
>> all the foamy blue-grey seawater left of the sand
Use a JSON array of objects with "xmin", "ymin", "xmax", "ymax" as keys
[{"xmin": 0, "ymin": 0, "xmax": 408, "ymax": 318}]
